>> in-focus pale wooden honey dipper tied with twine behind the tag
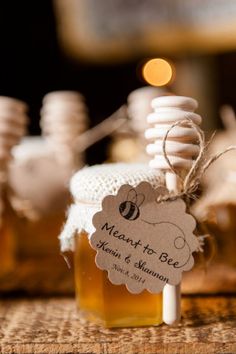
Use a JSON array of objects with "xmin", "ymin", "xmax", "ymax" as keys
[{"xmin": 145, "ymin": 96, "xmax": 202, "ymax": 325}]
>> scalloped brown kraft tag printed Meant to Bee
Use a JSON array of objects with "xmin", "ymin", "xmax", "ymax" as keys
[{"xmin": 90, "ymin": 182, "xmax": 199, "ymax": 294}]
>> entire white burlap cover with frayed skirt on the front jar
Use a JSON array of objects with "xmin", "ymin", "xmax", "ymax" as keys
[{"xmin": 59, "ymin": 163, "xmax": 163, "ymax": 252}]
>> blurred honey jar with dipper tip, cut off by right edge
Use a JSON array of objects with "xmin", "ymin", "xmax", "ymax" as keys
[{"xmin": 183, "ymin": 115, "xmax": 236, "ymax": 293}]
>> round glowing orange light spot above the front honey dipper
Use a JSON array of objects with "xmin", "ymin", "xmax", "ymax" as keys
[{"xmin": 142, "ymin": 58, "xmax": 173, "ymax": 86}]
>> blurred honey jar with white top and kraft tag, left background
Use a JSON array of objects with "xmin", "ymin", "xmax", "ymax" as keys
[{"xmin": 9, "ymin": 137, "xmax": 71, "ymax": 258}]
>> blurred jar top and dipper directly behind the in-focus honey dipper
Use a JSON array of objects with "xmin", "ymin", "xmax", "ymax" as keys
[{"xmin": 108, "ymin": 86, "xmax": 168, "ymax": 162}]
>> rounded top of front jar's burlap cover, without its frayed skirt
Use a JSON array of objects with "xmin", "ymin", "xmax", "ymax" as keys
[{"xmin": 70, "ymin": 163, "xmax": 161, "ymax": 203}]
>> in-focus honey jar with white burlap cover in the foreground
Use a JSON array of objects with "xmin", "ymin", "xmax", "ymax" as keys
[{"xmin": 60, "ymin": 163, "xmax": 162, "ymax": 327}]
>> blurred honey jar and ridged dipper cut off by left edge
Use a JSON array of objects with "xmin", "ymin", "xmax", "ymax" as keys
[{"xmin": 0, "ymin": 96, "xmax": 28, "ymax": 282}]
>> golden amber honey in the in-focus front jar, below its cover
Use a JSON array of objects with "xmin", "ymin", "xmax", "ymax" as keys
[{"xmin": 75, "ymin": 233, "xmax": 162, "ymax": 327}]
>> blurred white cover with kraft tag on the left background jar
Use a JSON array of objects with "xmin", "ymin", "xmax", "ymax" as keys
[{"xmin": 8, "ymin": 136, "xmax": 72, "ymax": 213}]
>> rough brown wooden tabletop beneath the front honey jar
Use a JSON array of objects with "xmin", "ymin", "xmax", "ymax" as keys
[{"xmin": 0, "ymin": 296, "xmax": 236, "ymax": 354}]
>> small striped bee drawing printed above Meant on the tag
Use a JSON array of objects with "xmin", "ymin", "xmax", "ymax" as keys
[{"xmin": 119, "ymin": 188, "xmax": 145, "ymax": 221}]
